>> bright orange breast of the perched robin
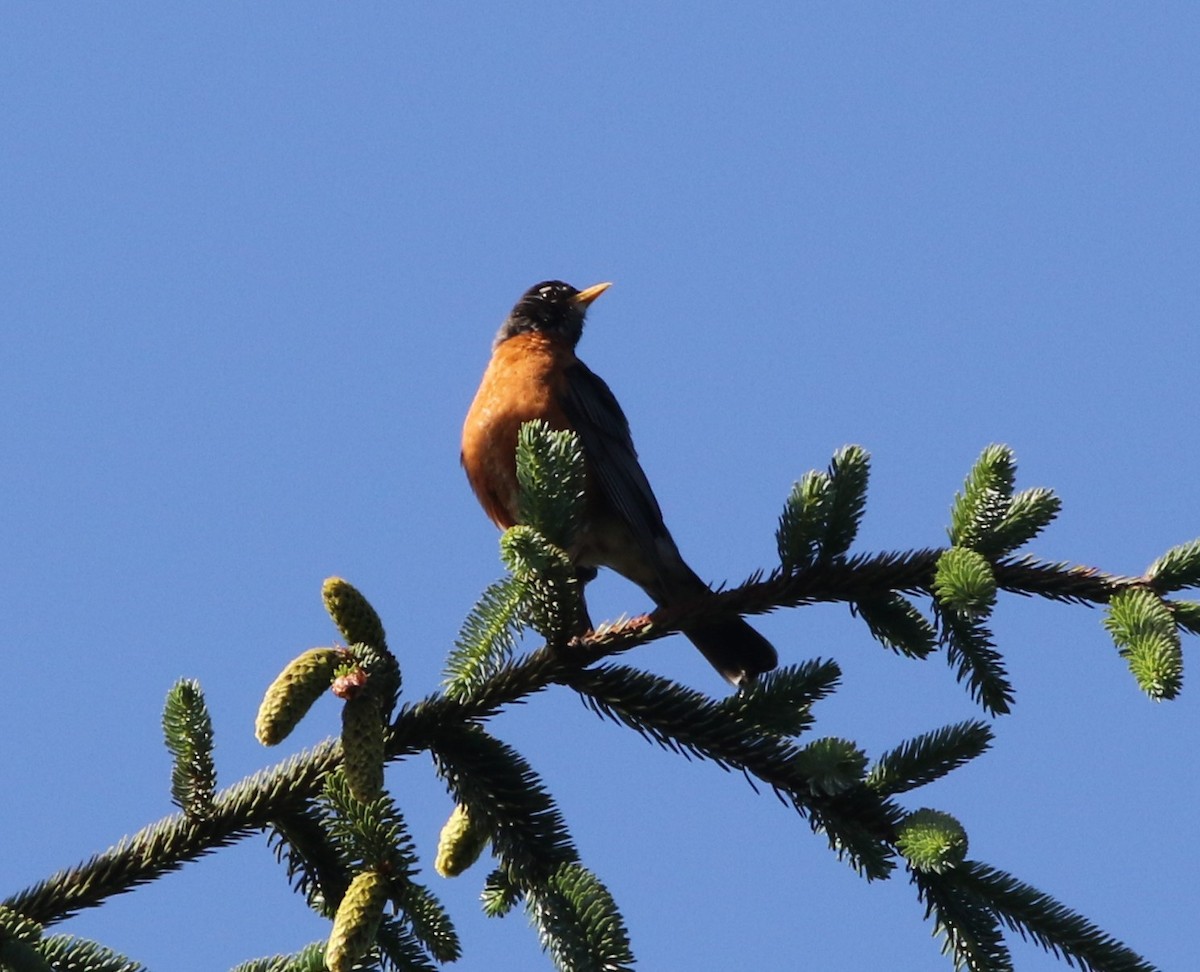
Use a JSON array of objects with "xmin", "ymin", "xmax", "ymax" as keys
[{"xmin": 462, "ymin": 332, "xmax": 575, "ymax": 529}]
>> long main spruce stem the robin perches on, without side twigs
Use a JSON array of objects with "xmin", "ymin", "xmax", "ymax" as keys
[{"xmin": 5, "ymin": 518, "xmax": 1161, "ymax": 924}]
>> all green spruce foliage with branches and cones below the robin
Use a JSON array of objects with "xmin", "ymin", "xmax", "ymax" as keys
[{"xmin": 0, "ymin": 434, "xmax": 1200, "ymax": 972}]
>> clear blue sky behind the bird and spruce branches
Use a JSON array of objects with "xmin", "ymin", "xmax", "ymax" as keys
[{"xmin": 0, "ymin": 2, "xmax": 1200, "ymax": 970}]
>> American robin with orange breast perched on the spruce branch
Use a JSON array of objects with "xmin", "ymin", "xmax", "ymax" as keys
[{"xmin": 462, "ymin": 281, "xmax": 779, "ymax": 685}]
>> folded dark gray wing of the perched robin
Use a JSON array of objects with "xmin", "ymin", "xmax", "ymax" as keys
[{"xmin": 563, "ymin": 361, "xmax": 674, "ymax": 566}]
